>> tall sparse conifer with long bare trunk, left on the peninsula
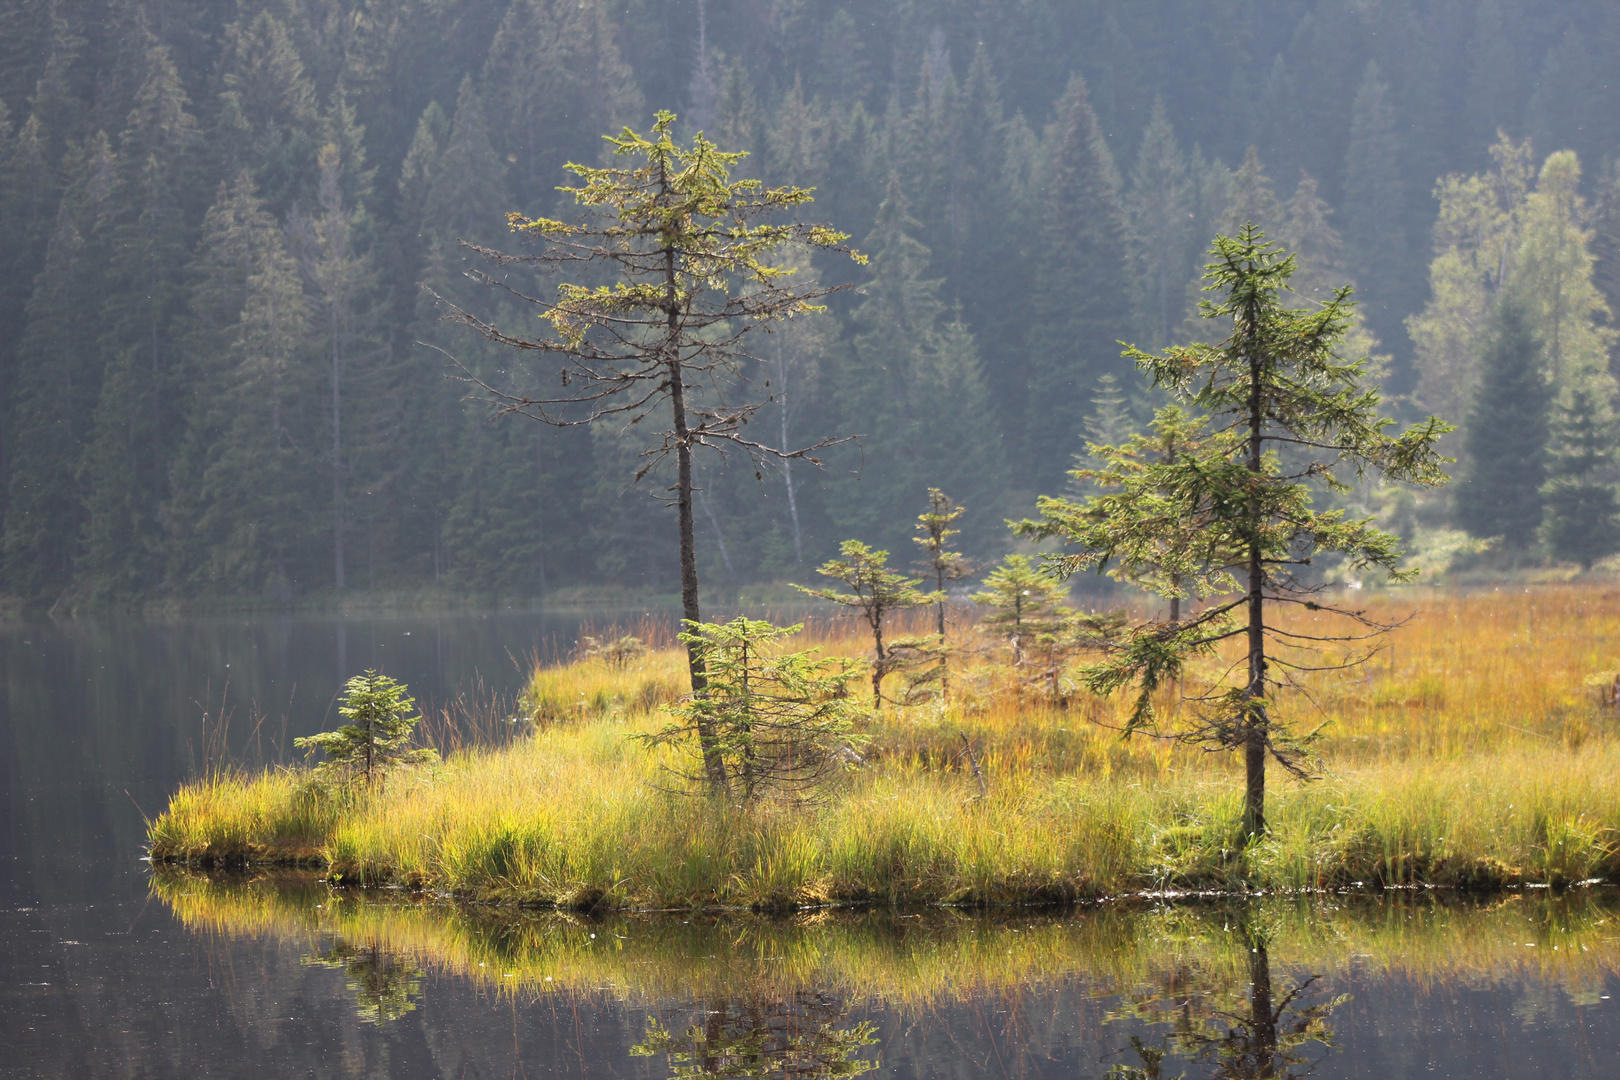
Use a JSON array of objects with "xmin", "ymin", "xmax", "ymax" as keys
[{"xmin": 439, "ymin": 112, "xmax": 867, "ymax": 799}]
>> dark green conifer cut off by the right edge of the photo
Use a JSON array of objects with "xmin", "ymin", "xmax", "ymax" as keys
[{"xmin": 1541, "ymin": 387, "xmax": 1620, "ymax": 570}]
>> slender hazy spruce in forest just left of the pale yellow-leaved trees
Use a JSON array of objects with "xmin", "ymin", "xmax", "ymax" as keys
[{"xmin": 1345, "ymin": 62, "xmax": 1413, "ymax": 351}]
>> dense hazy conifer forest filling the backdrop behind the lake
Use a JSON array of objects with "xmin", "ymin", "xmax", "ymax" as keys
[{"xmin": 0, "ymin": 0, "xmax": 1620, "ymax": 609}]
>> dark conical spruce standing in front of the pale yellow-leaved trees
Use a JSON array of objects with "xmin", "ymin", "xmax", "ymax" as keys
[{"xmin": 1456, "ymin": 295, "xmax": 1552, "ymax": 551}]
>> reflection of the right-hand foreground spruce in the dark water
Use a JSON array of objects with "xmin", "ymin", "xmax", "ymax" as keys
[{"xmin": 1108, "ymin": 925, "xmax": 1349, "ymax": 1080}]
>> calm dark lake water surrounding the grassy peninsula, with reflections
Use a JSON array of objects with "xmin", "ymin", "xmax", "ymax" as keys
[{"xmin": 0, "ymin": 615, "xmax": 1620, "ymax": 1078}]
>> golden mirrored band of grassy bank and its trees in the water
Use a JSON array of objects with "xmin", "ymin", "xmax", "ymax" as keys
[{"xmin": 152, "ymin": 870, "xmax": 1620, "ymax": 1078}]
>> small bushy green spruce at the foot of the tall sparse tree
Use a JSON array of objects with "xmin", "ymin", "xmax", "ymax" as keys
[{"xmin": 638, "ymin": 615, "xmax": 865, "ymax": 803}]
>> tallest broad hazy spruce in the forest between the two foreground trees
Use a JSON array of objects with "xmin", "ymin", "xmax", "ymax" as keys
[{"xmin": 1024, "ymin": 76, "xmax": 1129, "ymax": 487}]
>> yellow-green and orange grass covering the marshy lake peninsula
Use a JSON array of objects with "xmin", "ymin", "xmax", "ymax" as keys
[{"xmin": 151, "ymin": 588, "xmax": 1620, "ymax": 910}]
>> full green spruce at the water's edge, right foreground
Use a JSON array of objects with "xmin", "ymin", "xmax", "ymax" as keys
[{"xmin": 1027, "ymin": 223, "xmax": 1450, "ymax": 837}]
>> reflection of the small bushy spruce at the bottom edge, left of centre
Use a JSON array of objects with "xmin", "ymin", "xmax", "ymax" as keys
[{"xmin": 630, "ymin": 989, "xmax": 878, "ymax": 1080}]
